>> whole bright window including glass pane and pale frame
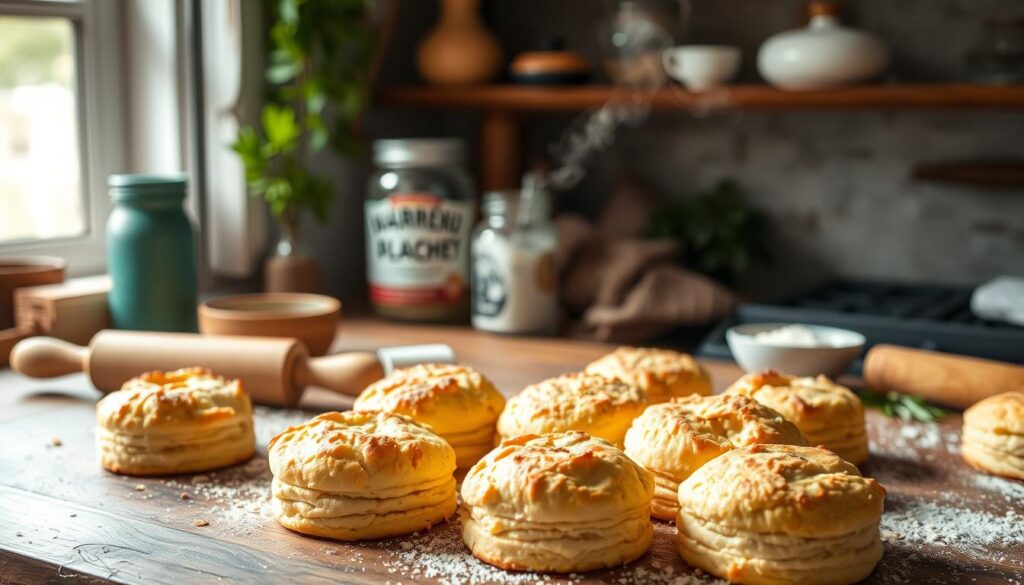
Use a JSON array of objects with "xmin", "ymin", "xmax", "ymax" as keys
[{"xmin": 0, "ymin": 0, "xmax": 125, "ymax": 274}]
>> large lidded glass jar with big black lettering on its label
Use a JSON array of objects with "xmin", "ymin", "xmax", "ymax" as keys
[{"xmin": 366, "ymin": 138, "xmax": 475, "ymax": 322}]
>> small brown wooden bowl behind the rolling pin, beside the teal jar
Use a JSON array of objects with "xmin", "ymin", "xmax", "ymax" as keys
[{"xmin": 199, "ymin": 293, "xmax": 341, "ymax": 356}]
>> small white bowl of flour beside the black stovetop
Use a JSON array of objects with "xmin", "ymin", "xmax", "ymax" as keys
[{"xmin": 725, "ymin": 323, "xmax": 866, "ymax": 378}]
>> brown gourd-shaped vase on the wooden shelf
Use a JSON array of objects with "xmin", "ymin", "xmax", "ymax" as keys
[{"xmin": 417, "ymin": 0, "xmax": 502, "ymax": 85}]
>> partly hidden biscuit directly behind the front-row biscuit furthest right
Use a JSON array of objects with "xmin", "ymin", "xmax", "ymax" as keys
[{"xmin": 626, "ymin": 395, "xmax": 807, "ymax": 520}]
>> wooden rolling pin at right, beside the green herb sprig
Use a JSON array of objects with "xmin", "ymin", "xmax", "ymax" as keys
[{"xmin": 864, "ymin": 345, "xmax": 1024, "ymax": 409}]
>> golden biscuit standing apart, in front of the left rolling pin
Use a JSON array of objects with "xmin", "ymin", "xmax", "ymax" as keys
[{"xmin": 96, "ymin": 368, "xmax": 256, "ymax": 475}]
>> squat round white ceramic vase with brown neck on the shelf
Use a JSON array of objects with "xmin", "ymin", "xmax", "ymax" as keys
[{"xmin": 758, "ymin": 2, "xmax": 889, "ymax": 89}]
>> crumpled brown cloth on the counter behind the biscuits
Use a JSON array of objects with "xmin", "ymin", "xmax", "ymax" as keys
[{"xmin": 555, "ymin": 186, "xmax": 736, "ymax": 343}]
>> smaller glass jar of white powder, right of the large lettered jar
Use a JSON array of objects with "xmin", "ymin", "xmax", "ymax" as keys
[{"xmin": 472, "ymin": 185, "xmax": 558, "ymax": 334}]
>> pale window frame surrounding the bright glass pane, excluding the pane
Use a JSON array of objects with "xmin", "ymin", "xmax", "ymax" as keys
[{"xmin": 0, "ymin": 0, "xmax": 127, "ymax": 276}]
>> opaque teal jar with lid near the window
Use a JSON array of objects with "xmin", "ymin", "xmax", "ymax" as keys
[{"xmin": 106, "ymin": 174, "xmax": 198, "ymax": 332}]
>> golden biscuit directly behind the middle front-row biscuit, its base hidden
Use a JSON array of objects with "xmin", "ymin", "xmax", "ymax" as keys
[{"xmin": 498, "ymin": 372, "xmax": 648, "ymax": 447}]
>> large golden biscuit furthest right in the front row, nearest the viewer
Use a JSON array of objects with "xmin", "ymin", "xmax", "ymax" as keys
[{"xmin": 676, "ymin": 445, "xmax": 885, "ymax": 585}]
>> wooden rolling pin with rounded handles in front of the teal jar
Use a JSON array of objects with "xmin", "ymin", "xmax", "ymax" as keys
[{"xmin": 10, "ymin": 330, "xmax": 454, "ymax": 406}]
